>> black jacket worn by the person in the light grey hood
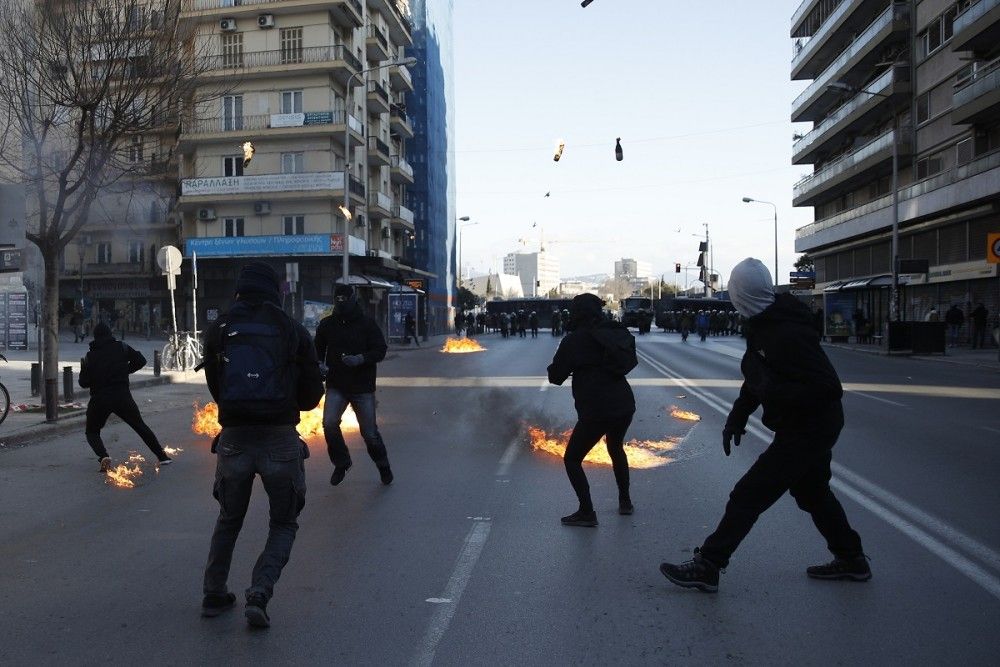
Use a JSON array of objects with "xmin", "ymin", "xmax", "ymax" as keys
[{"xmin": 726, "ymin": 294, "xmax": 844, "ymax": 431}]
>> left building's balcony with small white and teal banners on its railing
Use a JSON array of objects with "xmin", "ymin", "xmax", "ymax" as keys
[{"xmin": 180, "ymin": 111, "xmax": 364, "ymax": 153}]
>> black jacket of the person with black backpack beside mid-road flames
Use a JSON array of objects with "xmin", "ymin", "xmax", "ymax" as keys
[{"xmin": 548, "ymin": 322, "xmax": 635, "ymax": 420}]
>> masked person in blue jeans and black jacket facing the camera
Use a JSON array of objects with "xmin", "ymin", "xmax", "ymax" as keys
[{"xmin": 316, "ymin": 285, "xmax": 392, "ymax": 486}]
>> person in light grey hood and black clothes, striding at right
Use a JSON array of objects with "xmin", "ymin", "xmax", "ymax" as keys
[{"xmin": 660, "ymin": 258, "xmax": 872, "ymax": 592}]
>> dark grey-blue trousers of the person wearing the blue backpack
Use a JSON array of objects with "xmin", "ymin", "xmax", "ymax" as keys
[{"xmin": 204, "ymin": 425, "xmax": 306, "ymax": 599}]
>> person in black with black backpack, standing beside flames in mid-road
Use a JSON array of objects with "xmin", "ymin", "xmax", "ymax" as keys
[{"xmin": 548, "ymin": 294, "xmax": 638, "ymax": 526}]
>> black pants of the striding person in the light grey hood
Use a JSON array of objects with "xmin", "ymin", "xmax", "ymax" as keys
[{"xmin": 701, "ymin": 425, "xmax": 864, "ymax": 567}]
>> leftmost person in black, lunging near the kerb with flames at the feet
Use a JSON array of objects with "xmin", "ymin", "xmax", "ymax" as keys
[{"xmin": 79, "ymin": 322, "xmax": 171, "ymax": 472}]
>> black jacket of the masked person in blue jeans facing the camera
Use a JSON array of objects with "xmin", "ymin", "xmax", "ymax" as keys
[{"xmin": 316, "ymin": 306, "xmax": 389, "ymax": 394}]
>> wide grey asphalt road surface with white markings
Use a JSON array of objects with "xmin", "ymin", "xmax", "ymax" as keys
[{"xmin": 0, "ymin": 333, "xmax": 1000, "ymax": 665}]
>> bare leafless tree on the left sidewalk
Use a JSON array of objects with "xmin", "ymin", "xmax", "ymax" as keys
[{"xmin": 0, "ymin": 0, "xmax": 203, "ymax": 419}]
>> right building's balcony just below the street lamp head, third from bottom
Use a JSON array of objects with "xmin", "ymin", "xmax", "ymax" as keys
[{"xmin": 792, "ymin": 66, "xmax": 910, "ymax": 164}]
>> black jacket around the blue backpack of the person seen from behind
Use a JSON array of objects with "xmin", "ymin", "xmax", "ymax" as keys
[{"xmin": 204, "ymin": 298, "xmax": 323, "ymax": 426}]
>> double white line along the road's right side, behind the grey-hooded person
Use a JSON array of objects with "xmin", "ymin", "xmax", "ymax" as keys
[{"xmin": 638, "ymin": 352, "xmax": 1000, "ymax": 599}]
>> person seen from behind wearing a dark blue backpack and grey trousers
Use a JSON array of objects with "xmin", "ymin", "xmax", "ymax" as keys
[{"xmin": 201, "ymin": 262, "xmax": 323, "ymax": 627}]
